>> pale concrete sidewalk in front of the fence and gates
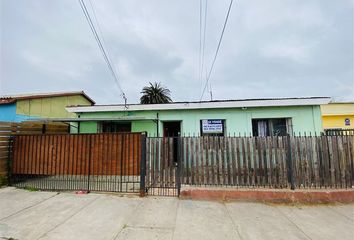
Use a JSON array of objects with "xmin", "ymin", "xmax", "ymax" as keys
[{"xmin": 0, "ymin": 188, "xmax": 354, "ymax": 240}]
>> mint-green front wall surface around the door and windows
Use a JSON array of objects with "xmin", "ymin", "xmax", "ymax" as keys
[{"xmin": 75, "ymin": 106, "xmax": 322, "ymax": 136}]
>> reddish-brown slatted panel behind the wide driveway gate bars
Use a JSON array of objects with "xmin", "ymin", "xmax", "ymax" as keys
[{"xmin": 12, "ymin": 133, "xmax": 141, "ymax": 176}]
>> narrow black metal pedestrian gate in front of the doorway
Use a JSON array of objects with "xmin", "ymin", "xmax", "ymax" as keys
[{"xmin": 143, "ymin": 137, "xmax": 181, "ymax": 196}]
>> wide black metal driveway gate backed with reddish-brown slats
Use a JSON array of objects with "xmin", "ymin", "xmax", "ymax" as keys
[{"xmin": 10, "ymin": 133, "xmax": 142, "ymax": 192}]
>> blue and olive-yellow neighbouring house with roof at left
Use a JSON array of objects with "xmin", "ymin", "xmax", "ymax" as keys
[{"xmin": 0, "ymin": 91, "xmax": 95, "ymax": 122}]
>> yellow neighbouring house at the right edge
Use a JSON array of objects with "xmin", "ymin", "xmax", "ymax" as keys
[{"xmin": 321, "ymin": 102, "xmax": 354, "ymax": 131}]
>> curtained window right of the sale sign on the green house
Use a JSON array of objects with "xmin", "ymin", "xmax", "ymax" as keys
[{"xmin": 252, "ymin": 118, "xmax": 292, "ymax": 137}]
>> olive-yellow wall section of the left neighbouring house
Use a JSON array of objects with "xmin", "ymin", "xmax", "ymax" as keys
[{"xmin": 16, "ymin": 95, "xmax": 91, "ymax": 118}]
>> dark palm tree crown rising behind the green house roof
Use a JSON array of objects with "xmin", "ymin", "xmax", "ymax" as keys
[{"xmin": 140, "ymin": 82, "xmax": 172, "ymax": 104}]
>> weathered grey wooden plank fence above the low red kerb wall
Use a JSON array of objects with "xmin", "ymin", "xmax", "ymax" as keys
[{"xmin": 177, "ymin": 135, "xmax": 354, "ymax": 188}]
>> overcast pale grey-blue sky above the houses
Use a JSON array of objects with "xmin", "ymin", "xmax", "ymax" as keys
[{"xmin": 0, "ymin": 0, "xmax": 354, "ymax": 104}]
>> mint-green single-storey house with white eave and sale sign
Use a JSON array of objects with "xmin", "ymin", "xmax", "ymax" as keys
[{"xmin": 67, "ymin": 97, "xmax": 330, "ymax": 137}]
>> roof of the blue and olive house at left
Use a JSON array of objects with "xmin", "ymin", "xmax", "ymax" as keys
[{"xmin": 0, "ymin": 91, "xmax": 95, "ymax": 105}]
